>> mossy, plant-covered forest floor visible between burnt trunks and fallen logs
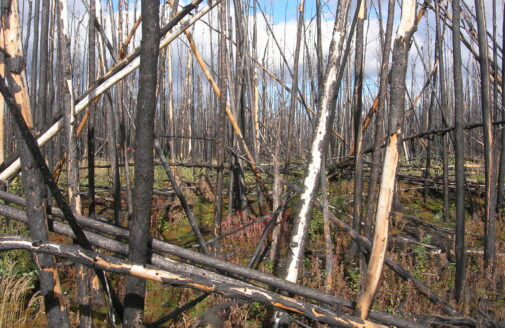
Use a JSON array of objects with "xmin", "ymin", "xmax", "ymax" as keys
[{"xmin": 0, "ymin": 161, "xmax": 505, "ymax": 328}]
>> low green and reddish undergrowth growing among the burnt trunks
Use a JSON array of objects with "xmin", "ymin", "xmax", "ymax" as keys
[{"xmin": 0, "ymin": 160, "xmax": 505, "ymax": 327}]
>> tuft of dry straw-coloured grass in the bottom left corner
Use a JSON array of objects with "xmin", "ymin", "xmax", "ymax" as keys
[{"xmin": 0, "ymin": 266, "xmax": 44, "ymax": 328}]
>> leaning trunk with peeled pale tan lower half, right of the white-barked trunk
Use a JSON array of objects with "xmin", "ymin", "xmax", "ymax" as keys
[{"xmin": 356, "ymin": 0, "xmax": 416, "ymax": 318}]
